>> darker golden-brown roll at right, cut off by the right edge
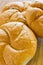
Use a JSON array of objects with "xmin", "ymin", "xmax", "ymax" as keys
[{"xmin": 23, "ymin": 1, "xmax": 43, "ymax": 38}]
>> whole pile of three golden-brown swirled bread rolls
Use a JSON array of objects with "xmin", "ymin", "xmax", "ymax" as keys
[{"xmin": 0, "ymin": 1, "xmax": 43, "ymax": 65}]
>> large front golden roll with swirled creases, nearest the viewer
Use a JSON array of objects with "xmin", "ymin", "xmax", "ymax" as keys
[{"xmin": 0, "ymin": 22, "xmax": 37, "ymax": 65}]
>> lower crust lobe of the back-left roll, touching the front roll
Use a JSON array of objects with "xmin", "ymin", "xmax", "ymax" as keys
[{"xmin": 0, "ymin": 9, "xmax": 26, "ymax": 25}]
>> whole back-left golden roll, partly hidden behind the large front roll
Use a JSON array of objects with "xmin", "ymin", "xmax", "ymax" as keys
[{"xmin": 0, "ymin": 2, "xmax": 30, "ymax": 25}]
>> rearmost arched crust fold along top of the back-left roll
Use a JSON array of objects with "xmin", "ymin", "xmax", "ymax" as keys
[{"xmin": 2, "ymin": 1, "xmax": 30, "ymax": 12}]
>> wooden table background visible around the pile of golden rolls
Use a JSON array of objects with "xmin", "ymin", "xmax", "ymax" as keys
[{"xmin": 0, "ymin": 0, "xmax": 43, "ymax": 65}]
